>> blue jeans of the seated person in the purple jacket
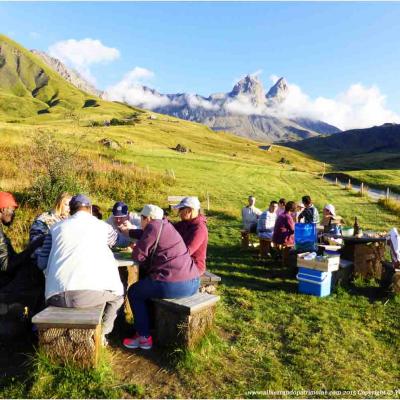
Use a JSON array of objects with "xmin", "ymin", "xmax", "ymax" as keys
[{"xmin": 128, "ymin": 278, "xmax": 200, "ymax": 336}]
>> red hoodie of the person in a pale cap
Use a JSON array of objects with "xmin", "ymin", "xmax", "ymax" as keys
[{"xmin": 174, "ymin": 215, "xmax": 208, "ymax": 275}]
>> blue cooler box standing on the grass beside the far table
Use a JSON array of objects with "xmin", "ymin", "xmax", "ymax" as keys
[{"xmin": 297, "ymin": 267, "xmax": 332, "ymax": 297}]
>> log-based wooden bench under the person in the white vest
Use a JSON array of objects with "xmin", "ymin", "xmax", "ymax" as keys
[{"xmin": 32, "ymin": 305, "xmax": 104, "ymax": 368}]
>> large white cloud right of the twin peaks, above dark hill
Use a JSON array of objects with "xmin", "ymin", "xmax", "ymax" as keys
[{"xmin": 268, "ymin": 79, "xmax": 400, "ymax": 129}]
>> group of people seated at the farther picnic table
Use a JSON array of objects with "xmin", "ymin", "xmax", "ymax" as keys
[{"xmin": 242, "ymin": 195, "xmax": 343, "ymax": 256}]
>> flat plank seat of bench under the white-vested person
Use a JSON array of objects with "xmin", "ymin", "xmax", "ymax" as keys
[{"xmin": 32, "ymin": 304, "xmax": 104, "ymax": 328}]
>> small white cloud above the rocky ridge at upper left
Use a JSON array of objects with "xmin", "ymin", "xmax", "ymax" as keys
[{"xmin": 49, "ymin": 38, "xmax": 120, "ymax": 83}]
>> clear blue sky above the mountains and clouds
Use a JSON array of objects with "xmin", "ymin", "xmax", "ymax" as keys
[{"xmin": 0, "ymin": 2, "xmax": 400, "ymax": 126}]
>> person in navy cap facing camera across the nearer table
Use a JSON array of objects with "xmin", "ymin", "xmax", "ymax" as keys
[{"xmin": 106, "ymin": 201, "xmax": 140, "ymax": 247}]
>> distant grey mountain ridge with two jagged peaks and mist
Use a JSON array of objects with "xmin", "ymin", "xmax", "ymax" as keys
[{"xmin": 126, "ymin": 75, "xmax": 340, "ymax": 142}]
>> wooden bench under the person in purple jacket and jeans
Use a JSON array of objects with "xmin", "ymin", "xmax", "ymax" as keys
[{"xmin": 153, "ymin": 293, "xmax": 219, "ymax": 348}]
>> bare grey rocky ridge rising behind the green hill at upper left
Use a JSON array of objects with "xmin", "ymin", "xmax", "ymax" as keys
[{"xmin": 31, "ymin": 50, "xmax": 103, "ymax": 97}]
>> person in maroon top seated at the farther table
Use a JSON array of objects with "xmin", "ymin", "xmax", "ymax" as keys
[{"xmin": 272, "ymin": 201, "xmax": 296, "ymax": 267}]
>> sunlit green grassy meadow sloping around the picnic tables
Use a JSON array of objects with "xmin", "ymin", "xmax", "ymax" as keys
[{"xmin": 0, "ymin": 110, "xmax": 400, "ymax": 398}]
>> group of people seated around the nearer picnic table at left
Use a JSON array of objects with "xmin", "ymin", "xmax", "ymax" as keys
[{"xmin": 0, "ymin": 192, "xmax": 208, "ymax": 349}]
